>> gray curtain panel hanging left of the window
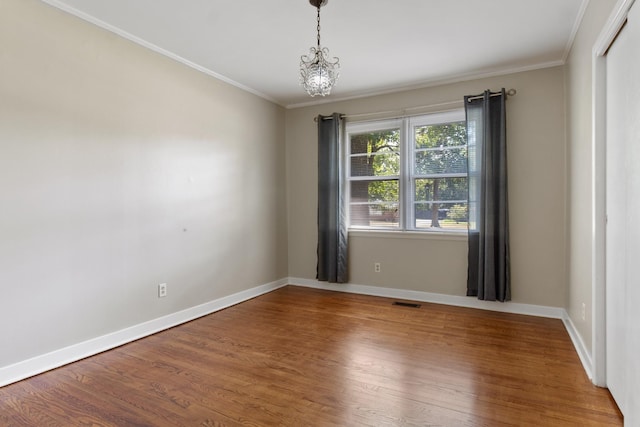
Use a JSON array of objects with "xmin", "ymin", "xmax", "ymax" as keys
[{"xmin": 316, "ymin": 113, "xmax": 347, "ymax": 283}]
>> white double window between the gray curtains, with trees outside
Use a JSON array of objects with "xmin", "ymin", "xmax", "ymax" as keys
[{"xmin": 346, "ymin": 110, "xmax": 469, "ymax": 231}]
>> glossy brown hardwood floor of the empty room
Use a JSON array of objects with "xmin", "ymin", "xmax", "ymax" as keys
[{"xmin": 0, "ymin": 286, "xmax": 622, "ymax": 427}]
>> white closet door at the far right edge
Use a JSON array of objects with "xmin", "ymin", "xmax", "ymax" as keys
[{"xmin": 606, "ymin": 0, "xmax": 640, "ymax": 426}]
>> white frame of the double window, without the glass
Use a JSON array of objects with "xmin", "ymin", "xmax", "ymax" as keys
[{"xmin": 344, "ymin": 108, "xmax": 467, "ymax": 235}]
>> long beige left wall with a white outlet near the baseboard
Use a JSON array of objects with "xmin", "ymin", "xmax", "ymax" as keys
[{"xmin": 0, "ymin": 0, "xmax": 287, "ymax": 368}]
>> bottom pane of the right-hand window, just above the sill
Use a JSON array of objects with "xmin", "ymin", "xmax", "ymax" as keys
[{"xmin": 414, "ymin": 202, "xmax": 469, "ymax": 231}]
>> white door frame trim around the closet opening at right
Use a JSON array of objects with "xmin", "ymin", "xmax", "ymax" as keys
[{"xmin": 591, "ymin": 0, "xmax": 635, "ymax": 387}]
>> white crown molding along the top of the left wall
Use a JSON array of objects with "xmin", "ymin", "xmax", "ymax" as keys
[{"xmin": 42, "ymin": 0, "xmax": 283, "ymax": 106}]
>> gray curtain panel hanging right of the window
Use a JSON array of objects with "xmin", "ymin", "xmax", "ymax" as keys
[{"xmin": 464, "ymin": 89, "xmax": 511, "ymax": 302}]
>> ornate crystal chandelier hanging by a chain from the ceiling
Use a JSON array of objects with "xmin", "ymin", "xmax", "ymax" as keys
[{"xmin": 300, "ymin": 0, "xmax": 340, "ymax": 96}]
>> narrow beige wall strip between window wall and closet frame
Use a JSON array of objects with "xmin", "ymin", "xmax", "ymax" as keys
[{"xmin": 566, "ymin": 0, "xmax": 616, "ymax": 349}]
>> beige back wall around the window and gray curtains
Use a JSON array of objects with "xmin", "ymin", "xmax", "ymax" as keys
[{"xmin": 286, "ymin": 67, "xmax": 566, "ymax": 307}]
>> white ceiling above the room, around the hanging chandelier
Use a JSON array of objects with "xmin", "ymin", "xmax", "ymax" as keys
[{"xmin": 43, "ymin": 0, "xmax": 588, "ymax": 107}]
